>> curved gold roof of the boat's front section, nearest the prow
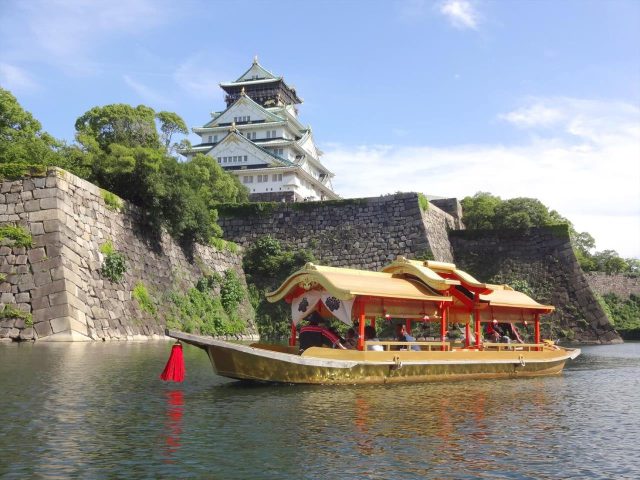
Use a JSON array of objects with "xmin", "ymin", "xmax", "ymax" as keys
[{"xmin": 266, "ymin": 263, "xmax": 452, "ymax": 302}]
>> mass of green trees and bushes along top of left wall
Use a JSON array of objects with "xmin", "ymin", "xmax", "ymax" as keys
[{"xmin": 0, "ymin": 88, "xmax": 248, "ymax": 246}]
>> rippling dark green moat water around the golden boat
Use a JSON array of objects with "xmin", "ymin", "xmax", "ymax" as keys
[{"xmin": 0, "ymin": 342, "xmax": 640, "ymax": 479}]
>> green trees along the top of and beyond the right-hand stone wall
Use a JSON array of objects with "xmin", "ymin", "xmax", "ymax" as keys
[{"xmin": 460, "ymin": 192, "xmax": 640, "ymax": 273}]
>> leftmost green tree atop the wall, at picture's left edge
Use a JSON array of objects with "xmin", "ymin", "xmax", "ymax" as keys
[{"xmin": 0, "ymin": 87, "xmax": 64, "ymax": 165}]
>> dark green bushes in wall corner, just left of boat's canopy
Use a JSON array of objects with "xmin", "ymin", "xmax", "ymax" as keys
[{"xmin": 243, "ymin": 236, "xmax": 314, "ymax": 339}]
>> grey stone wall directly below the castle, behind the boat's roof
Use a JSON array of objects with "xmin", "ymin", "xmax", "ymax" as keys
[{"xmin": 219, "ymin": 193, "xmax": 455, "ymax": 270}]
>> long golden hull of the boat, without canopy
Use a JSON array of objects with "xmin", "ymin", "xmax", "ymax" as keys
[{"xmin": 169, "ymin": 332, "xmax": 580, "ymax": 384}]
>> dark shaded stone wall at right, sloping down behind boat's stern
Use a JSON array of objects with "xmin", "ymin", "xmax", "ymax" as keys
[{"xmin": 449, "ymin": 226, "xmax": 621, "ymax": 343}]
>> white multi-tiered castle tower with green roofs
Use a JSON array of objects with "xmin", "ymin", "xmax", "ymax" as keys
[{"xmin": 180, "ymin": 58, "xmax": 339, "ymax": 201}]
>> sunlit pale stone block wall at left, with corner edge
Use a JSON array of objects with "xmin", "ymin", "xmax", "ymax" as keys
[{"xmin": 0, "ymin": 170, "xmax": 253, "ymax": 341}]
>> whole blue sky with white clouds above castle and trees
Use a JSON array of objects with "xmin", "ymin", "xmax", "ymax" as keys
[{"xmin": 0, "ymin": 0, "xmax": 640, "ymax": 258}]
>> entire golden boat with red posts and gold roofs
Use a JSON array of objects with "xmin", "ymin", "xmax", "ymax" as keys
[{"xmin": 167, "ymin": 257, "xmax": 580, "ymax": 384}]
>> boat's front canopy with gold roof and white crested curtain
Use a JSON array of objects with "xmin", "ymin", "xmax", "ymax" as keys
[{"xmin": 266, "ymin": 263, "xmax": 453, "ymax": 324}]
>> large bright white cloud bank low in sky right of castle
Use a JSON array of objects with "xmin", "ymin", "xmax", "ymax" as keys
[{"xmin": 323, "ymin": 98, "xmax": 640, "ymax": 257}]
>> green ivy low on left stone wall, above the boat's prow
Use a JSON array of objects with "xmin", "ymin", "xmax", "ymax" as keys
[{"xmin": 167, "ymin": 270, "xmax": 247, "ymax": 336}]
